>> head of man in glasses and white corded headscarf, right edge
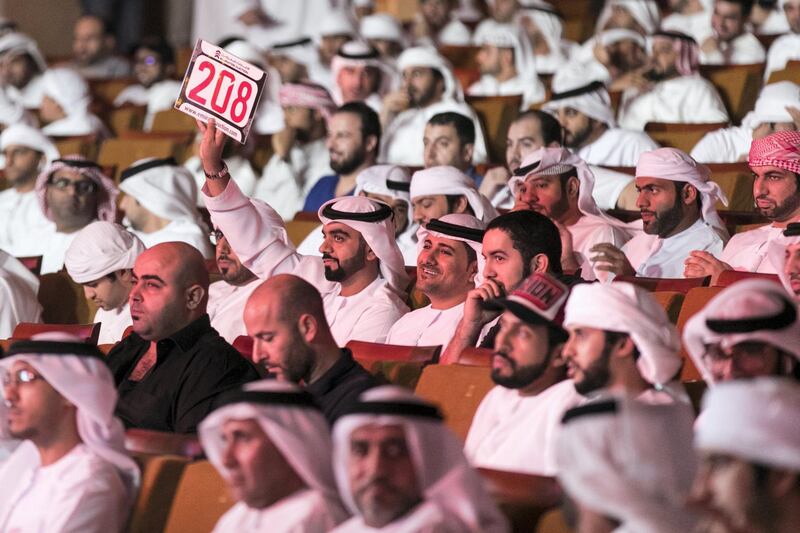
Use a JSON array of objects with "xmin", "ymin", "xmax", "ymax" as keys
[{"xmin": 683, "ymin": 279, "xmax": 800, "ymax": 385}]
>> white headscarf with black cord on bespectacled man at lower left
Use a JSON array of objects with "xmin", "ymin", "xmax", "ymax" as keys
[{"xmin": 0, "ymin": 332, "xmax": 139, "ymax": 505}]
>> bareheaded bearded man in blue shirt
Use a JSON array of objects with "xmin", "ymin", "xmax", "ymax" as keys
[{"xmin": 303, "ymin": 102, "xmax": 381, "ymax": 211}]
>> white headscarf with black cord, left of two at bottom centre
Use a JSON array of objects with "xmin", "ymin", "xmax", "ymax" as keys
[{"xmin": 198, "ymin": 380, "xmax": 338, "ymax": 499}]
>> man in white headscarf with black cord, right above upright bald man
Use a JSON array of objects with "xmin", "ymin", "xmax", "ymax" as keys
[{"xmin": 119, "ymin": 157, "xmax": 214, "ymax": 258}]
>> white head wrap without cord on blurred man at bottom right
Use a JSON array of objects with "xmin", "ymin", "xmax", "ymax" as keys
[{"xmin": 694, "ymin": 377, "xmax": 800, "ymax": 472}]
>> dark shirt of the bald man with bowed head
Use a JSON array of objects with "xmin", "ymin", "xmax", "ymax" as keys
[{"xmin": 306, "ymin": 348, "xmax": 379, "ymax": 424}]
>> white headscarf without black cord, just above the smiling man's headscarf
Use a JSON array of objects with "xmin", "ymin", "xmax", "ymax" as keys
[{"xmin": 411, "ymin": 165, "xmax": 497, "ymax": 222}]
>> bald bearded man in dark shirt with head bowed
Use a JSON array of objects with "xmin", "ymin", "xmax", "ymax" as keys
[{"xmin": 244, "ymin": 274, "xmax": 377, "ymax": 423}]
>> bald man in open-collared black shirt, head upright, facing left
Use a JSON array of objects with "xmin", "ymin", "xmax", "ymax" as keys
[{"xmin": 108, "ymin": 242, "xmax": 258, "ymax": 433}]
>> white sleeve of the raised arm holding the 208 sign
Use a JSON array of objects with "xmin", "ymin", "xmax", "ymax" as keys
[{"xmin": 202, "ymin": 180, "xmax": 301, "ymax": 279}]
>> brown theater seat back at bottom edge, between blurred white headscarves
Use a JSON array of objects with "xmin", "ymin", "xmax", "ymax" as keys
[{"xmin": 478, "ymin": 468, "xmax": 563, "ymax": 531}]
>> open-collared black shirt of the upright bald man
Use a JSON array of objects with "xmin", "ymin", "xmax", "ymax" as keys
[{"xmin": 108, "ymin": 315, "xmax": 259, "ymax": 433}]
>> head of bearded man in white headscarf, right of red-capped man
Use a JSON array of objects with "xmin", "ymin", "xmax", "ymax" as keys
[{"xmin": 562, "ymin": 282, "xmax": 682, "ymax": 403}]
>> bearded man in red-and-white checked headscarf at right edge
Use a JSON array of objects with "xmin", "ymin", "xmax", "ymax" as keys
[{"xmin": 686, "ymin": 131, "xmax": 800, "ymax": 278}]
